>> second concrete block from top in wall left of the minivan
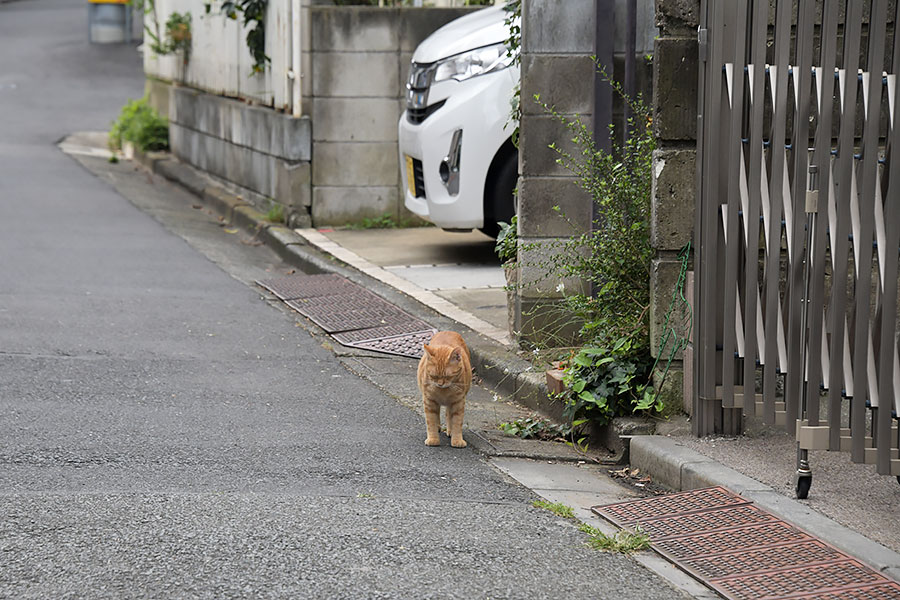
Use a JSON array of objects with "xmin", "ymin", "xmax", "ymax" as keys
[{"xmin": 312, "ymin": 52, "xmax": 400, "ymax": 98}]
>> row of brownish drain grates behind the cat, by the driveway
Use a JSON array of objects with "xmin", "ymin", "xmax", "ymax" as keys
[{"xmin": 256, "ymin": 274, "xmax": 436, "ymax": 358}]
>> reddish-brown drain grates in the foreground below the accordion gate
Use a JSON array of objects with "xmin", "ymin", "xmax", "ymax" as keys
[{"xmin": 593, "ymin": 488, "xmax": 900, "ymax": 600}]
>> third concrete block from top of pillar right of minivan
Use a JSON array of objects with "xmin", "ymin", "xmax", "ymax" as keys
[{"xmin": 519, "ymin": 114, "xmax": 593, "ymax": 177}]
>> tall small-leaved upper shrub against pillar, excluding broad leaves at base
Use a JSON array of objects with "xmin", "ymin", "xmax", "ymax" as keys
[{"xmin": 537, "ymin": 78, "xmax": 656, "ymax": 349}]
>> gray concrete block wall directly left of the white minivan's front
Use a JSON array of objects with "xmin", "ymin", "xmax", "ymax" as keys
[{"xmin": 305, "ymin": 6, "xmax": 471, "ymax": 226}]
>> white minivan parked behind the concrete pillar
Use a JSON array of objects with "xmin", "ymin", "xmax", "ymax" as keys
[{"xmin": 399, "ymin": 3, "xmax": 519, "ymax": 237}]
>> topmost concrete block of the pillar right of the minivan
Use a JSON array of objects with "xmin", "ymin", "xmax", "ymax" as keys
[{"xmin": 522, "ymin": 0, "xmax": 595, "ymax": 54}]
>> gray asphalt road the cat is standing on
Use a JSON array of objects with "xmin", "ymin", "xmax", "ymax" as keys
[{"xmin": 0, "ymin": 0, "xmax": 679, "ymax": 599}]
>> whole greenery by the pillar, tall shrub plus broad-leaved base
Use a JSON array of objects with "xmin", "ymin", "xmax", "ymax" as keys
[{"xmin": 521, "ymin": 71, "xmax": 661, "ymax": 427}]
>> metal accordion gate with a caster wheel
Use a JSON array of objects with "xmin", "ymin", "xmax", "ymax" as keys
[{"xmin": 693, "ymin": 0, "xmax": 900, "ymax": 497}]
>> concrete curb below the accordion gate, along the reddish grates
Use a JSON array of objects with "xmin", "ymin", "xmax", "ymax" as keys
[{"xmin": 630, "ymin": 435, "xmax": 900, "ymax": 581}]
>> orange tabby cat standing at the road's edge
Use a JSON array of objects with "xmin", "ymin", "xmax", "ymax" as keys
[{"xmin": 416, "ymin": 331, "xmax": 472, "ymax": 448}]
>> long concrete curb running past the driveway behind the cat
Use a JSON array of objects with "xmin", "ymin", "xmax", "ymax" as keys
[{"xmin": 134, "ymin": 152, "xmax": 559, "ymax": 415}]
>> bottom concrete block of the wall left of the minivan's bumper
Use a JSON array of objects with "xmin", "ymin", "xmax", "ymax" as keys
[{"xmin": 312, "ymin": 186, "xmax": 400, "ymax": 227}]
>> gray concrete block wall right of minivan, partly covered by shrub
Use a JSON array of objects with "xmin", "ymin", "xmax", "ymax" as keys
[{"xmin": 515, "ymin": 0, "xmax": 656, "ymax": 345}]
